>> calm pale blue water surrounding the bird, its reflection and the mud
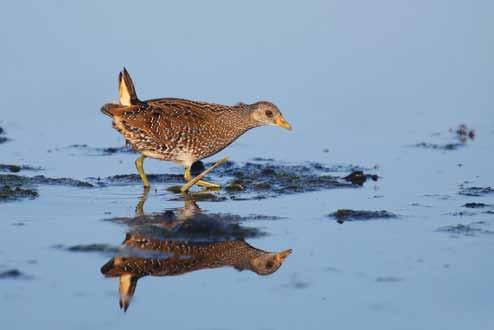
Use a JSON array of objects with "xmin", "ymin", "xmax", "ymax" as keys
[{"xmin": 0, "ymin": 1, "xmax": 494, "ymax": 329}]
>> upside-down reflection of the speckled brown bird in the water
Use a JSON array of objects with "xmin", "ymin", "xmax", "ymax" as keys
[{"xmin": 101, "ymin": 190, "xmax": 291, "ymax": 311}]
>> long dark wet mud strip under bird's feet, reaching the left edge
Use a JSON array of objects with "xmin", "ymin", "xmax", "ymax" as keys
[{"xmin": 0, "ymin": 158, "xmax": 379, "ymax": 202}]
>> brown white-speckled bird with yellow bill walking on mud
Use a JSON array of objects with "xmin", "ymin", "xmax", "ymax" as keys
[{"xmin": 101, "ymin": 69, "xmax": 291, "ymax": 191}]
